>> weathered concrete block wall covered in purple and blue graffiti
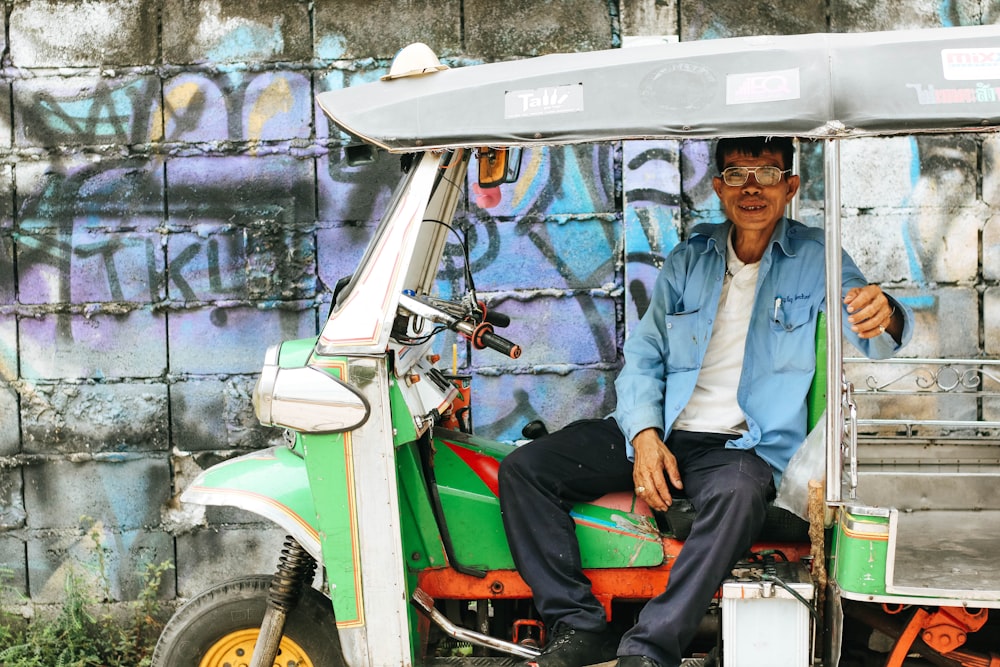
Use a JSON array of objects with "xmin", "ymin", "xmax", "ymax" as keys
[{"xmin": 0, "ymin": 0, "xmax": 1000, "ymax": 604}]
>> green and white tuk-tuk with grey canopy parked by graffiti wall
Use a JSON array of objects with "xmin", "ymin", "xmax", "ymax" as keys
[{"xmin": 153, "ymin": 26, "xmax": 1000, "ymax": 667}]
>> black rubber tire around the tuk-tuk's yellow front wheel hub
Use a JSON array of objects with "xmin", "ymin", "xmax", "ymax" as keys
[{"xmin": 152, "ymin": 575, "xmax": 346, "ymax": 667}]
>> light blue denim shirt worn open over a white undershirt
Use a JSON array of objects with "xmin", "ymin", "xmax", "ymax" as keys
[{"xmin": 612, "ymin": 218, "xmax": 913, "ymax": 483}]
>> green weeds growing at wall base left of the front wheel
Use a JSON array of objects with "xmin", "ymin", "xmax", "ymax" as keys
[{"xmin": 0, "ymin": 562, "xmax": 173, "ymax": 667}]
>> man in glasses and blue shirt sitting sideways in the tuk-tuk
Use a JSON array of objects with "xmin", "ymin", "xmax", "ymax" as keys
[{"xmin": 500, "ymin": 137, "xmax": 912, "ymax": 667}]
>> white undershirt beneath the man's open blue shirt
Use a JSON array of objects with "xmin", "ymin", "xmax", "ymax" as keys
[{"xmin": 674, "ymin": 234, "xmax": 760, "ymax": 435}]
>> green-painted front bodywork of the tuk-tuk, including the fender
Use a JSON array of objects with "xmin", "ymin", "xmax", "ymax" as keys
[{"xmin": 186, "ymin": 339, "xmax": 663, "ymax": 624}]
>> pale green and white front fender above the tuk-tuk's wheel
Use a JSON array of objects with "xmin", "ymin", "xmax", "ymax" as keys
[{"xmin": 181, "ymin": 447, "xmax": 323, "ymax": 563}]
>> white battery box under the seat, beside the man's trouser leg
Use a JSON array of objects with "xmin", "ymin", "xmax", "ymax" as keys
[{"xmin": 722, "ymin": 562, "xmax": 815, "ymax": 667}]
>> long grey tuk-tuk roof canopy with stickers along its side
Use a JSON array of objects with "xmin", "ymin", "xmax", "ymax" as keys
[{"xmin": 317, "ymin": 26, "xmax": 1000, "ymax": 152}]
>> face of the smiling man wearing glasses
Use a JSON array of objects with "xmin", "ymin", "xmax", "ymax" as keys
[{"xmin": 712, "ymin": 150, "xmax": 799, "ymax": 238}]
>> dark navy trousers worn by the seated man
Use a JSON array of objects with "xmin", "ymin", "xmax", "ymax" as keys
[{"xmin": 499, "ymin": 419, "xmax": 774, "ymax": 667}]
